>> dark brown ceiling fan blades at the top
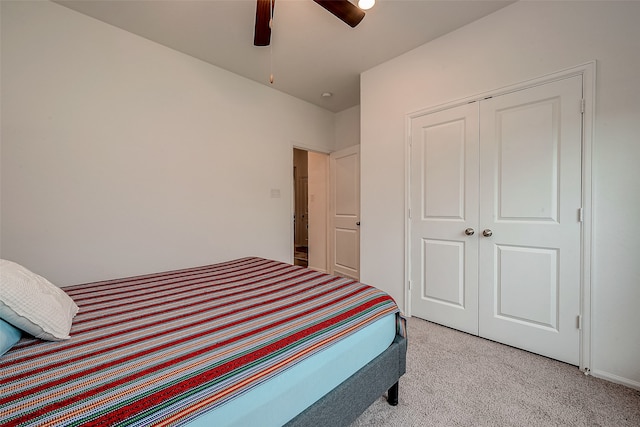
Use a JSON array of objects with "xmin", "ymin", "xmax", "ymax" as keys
[{"xmin": 253, "ymin": 0, "xmax": 364, "ymax": 46}]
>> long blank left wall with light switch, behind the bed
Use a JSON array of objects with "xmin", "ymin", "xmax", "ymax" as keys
[{"xmin": 0, "ymin": 1, "xmax": 335, "ymax": 285}]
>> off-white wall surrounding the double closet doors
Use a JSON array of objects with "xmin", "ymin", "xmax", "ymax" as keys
[{"xmin": 361, "ymin": 1, "xmax": 640, "ymax": 388}]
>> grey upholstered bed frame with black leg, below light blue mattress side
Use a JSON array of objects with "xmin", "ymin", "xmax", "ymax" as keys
[{"xmin": 286, "ymin": 335, "xmax": 407, "ymax": 427}]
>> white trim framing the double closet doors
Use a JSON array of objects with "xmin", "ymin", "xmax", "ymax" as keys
[{"xmin": 403, "ymin": 60, "xmax": 596, "ymax": 374}]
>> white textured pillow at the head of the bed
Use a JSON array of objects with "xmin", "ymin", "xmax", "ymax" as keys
[{"xmin": 0, "ymin": 259, "xmax": 78, "ymax": 341}]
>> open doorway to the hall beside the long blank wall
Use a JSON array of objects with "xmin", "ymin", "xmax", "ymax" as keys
[{"xmin": 293, "ymin": 148, "xmax": 329, "ymax": 272}]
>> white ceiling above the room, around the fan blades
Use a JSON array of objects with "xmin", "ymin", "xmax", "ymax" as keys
[{"xmin": 54, "ymin": 0, "xmax": 513, "ymax": 112}]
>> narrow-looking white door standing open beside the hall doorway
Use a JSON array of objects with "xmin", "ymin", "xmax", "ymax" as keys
[{"xmin": 329, "ymin": 146, "xmax": 360, "ymax": 280}]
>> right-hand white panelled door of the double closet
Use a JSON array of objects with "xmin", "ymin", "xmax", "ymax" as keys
[{"xmin": 478, "ymin": 76, "xmax": 582, "ymax": 365}]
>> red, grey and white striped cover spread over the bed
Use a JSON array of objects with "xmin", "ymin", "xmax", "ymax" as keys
[{"xmin": 0, "ymin": 257, "xmax": 398, "ymax": 426}]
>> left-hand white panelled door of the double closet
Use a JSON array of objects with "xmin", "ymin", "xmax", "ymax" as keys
[{"xmin": 410, "ymin": 103, "xmax": 478, "ymax": 335}]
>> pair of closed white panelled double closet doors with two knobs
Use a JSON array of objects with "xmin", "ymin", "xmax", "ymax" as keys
[{"xmin": 409, "ymin": 76, "xmax": 582, "ymax": 365}]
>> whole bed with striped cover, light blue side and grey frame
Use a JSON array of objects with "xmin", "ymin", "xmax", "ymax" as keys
[{"xmin": 0, "ymin": 257, "xmax": 407, "ymax": 426}]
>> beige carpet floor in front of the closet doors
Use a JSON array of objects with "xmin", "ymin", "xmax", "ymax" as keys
[{"xmin": 352, "ymin": 318, "xmax": 640, "ymax": 427}]
